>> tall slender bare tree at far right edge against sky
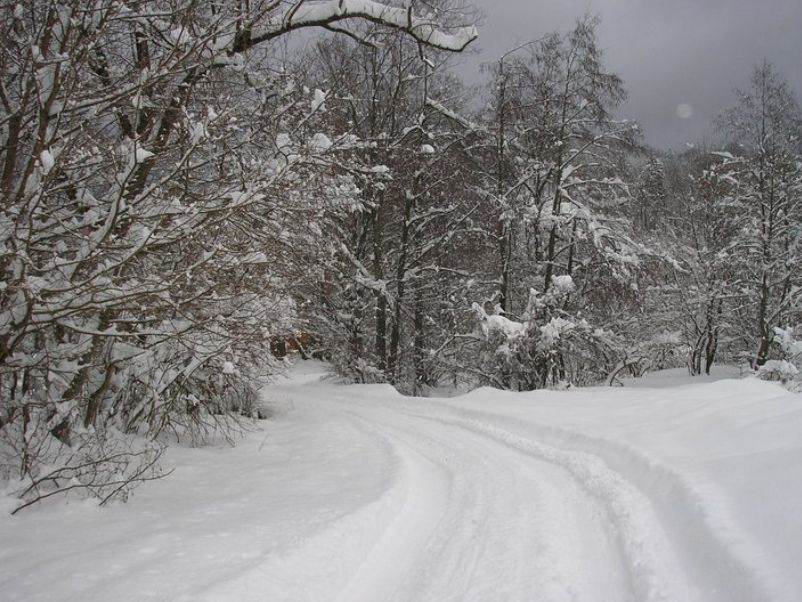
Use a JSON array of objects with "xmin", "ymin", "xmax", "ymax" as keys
[{"xmin": 709, "ymin": 72, "xmax": 802, "ymax": 366}]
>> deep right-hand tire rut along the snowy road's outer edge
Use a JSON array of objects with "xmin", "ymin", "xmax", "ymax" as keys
[{"xmin": 405, "ymin": 404, "xmax": 790, "ymax": 602}]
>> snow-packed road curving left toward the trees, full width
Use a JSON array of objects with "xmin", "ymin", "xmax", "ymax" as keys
[{"xmin": 253, "ymin": 360, "xmax": 790, "ymax": 602}]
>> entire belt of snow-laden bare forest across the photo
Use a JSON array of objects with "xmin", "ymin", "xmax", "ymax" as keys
[{"xmin": 0, "ymin": 0, "xmax": 802, "ymax": 508}]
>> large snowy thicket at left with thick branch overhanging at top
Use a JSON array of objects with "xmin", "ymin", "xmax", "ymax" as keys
[{"xmin": 0, "ymin": 0, "xmax": 476, "ymax": 510}]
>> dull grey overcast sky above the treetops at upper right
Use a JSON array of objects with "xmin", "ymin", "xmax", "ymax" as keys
[{"xmin": 460, "ymin": 0, "xmax": 802, "ymax": 148}]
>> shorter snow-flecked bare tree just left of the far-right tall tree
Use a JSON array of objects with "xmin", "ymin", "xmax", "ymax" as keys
[{"xmin": 630, "ymin": 151, "xmax": 735, "ymax": 374}]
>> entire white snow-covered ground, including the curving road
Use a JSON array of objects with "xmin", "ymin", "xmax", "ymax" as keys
[{"xmin": 0, "ymin": 362, "xmax": 802, "ymax": 602}]
